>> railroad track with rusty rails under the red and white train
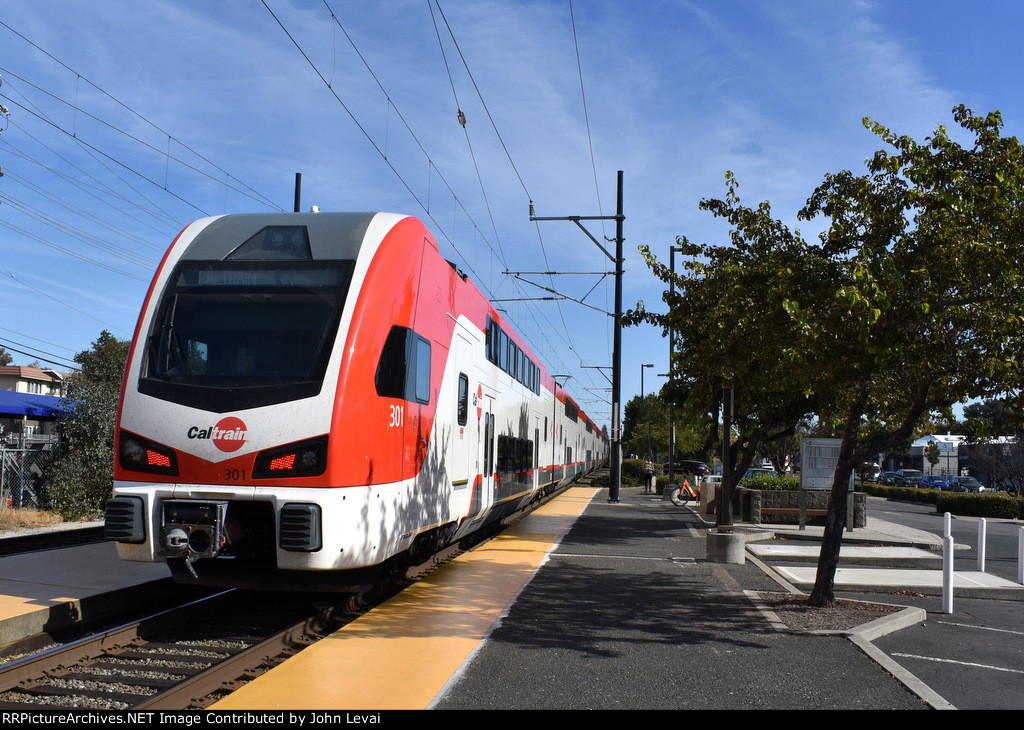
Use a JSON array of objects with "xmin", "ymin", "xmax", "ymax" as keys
[{"xmin": 0, "ymin": 479, "xmax": 581, "ymax": 712}]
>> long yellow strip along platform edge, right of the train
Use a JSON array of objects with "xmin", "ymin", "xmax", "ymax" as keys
[{"xmin": 211, "ymin": 487, "xmax": 598, "ymax": 710}]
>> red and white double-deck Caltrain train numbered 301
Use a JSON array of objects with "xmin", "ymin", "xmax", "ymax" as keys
[{"xmin": 105, "ymin": 208, "xmax": 608, "ymax": 590}]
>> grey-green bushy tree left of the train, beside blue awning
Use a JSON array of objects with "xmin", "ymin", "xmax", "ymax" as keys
[{"xmin": 49, "ymin": 330, "xmax": 129, "ymax": 519}]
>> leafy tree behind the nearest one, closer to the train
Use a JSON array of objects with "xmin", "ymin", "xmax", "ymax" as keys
[{"xmin": 624, "ymin": 173, "xmax": 816, "ymax": 525}]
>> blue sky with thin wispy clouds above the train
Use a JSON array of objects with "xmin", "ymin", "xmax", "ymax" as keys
[{"xmin": 0, "ymin": 0, "xmax": 1024, "ymax": 424}]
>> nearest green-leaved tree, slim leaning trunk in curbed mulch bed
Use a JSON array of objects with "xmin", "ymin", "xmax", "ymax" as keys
[{"xmin": 787, "ymin": 105, "xmax": 1024, "ymax": 605}]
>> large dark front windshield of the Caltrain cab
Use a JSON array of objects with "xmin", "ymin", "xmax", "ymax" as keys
[{"xmin": 139, "ymin": 260, "xmax": 354, "ymax": 413}]
